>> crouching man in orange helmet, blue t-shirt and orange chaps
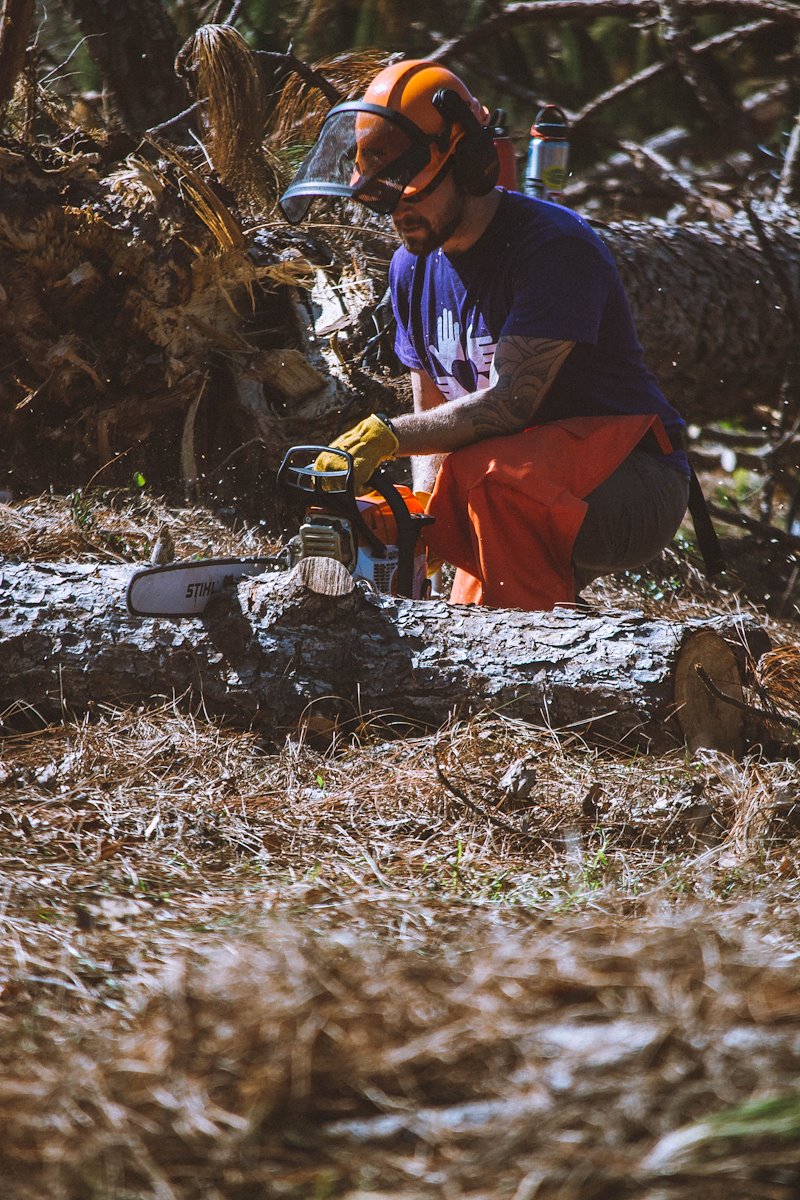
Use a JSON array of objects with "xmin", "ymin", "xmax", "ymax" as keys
[{"xmin": 281, "ymin": 60, "xmax": 690, "ymax": 610}]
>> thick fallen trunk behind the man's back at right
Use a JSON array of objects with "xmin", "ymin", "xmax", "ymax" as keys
[{"xmin": 597, "ymin": 214, "xmax": 800, "ymax": 425}]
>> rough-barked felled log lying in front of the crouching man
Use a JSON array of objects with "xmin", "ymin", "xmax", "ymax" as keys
[{"xmin": 0, "ymin": 559, "xmax": 769, "ymax": 752}]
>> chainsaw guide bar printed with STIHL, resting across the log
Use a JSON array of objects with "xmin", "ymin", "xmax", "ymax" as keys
[{"xmin": 125, "ymin": 554, "xmax": 291, "ymax": 617}]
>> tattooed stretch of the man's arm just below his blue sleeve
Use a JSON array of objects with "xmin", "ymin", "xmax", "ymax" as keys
[{"xmin": 471, "ymin": 337, "xmax": 575, "ymax": 439}]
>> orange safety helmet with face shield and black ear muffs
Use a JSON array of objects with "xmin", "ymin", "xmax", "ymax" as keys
[{"xmin": 279, "ymin": 59, "xmax": 498, "ymax": 224}]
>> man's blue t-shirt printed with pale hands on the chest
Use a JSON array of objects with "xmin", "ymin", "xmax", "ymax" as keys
[{"xmin": 389, "ymin": 192, "xmax": 688, "ymax": 472}]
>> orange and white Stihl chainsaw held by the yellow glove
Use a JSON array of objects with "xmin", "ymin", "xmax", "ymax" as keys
[{"xmin": 125, "ymin": 446, "xmax": 433, "ymax": 617}]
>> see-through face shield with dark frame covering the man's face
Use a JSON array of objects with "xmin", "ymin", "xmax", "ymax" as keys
[{"xmin": 278, "ymin": 101, "xmax": 450, "ymax": 224}]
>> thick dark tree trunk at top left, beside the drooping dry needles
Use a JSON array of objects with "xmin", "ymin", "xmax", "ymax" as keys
[{"xmin": 64, "ymin": 0, "xmax": 188, "ymax": 136}]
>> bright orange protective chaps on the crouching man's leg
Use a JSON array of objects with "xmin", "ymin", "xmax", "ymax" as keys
[{"xmin": 427, "ymin": 414, "xmax": 672, "ymax": 610}]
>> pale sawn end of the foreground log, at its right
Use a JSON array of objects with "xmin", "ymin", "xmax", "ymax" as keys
[{"xmin": 674, "ymin": 630, "xmax": 745, "ymax": 755}]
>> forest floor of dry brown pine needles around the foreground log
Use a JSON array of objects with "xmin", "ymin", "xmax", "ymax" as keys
[{"xmin": 0, "ymin": 497, "xmax": 800, "ymax": 1200}]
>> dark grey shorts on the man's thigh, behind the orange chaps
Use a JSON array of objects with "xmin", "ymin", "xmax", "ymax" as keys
[{"xmin": 572, "ymin": 450, "xmax": 688, "ymax": 592}]
